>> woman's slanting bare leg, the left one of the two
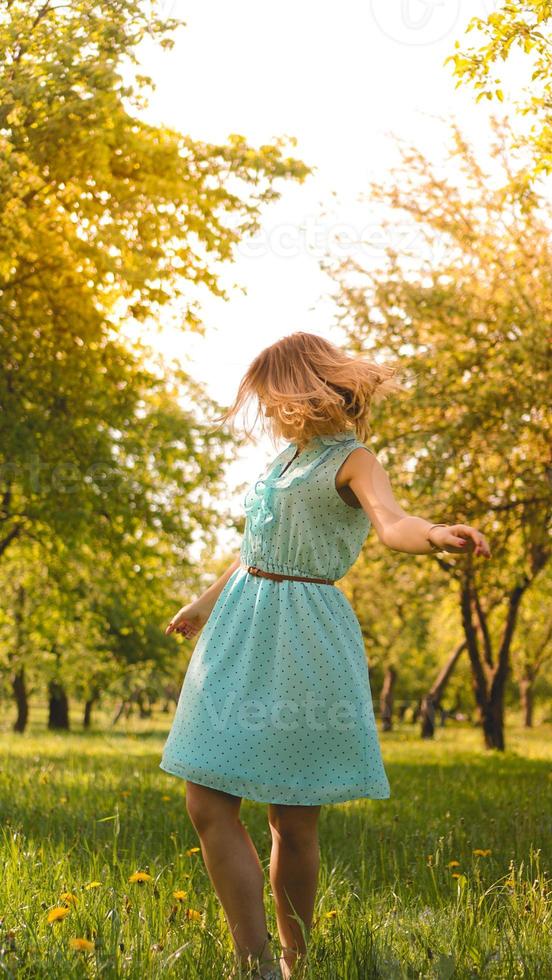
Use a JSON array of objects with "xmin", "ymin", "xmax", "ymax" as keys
[{"xmin": 186, "ymin": 781, "xmax": 274, "ymax": 965}]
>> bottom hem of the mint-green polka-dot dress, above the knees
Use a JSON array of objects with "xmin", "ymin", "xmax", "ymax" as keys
[{"xmin": 159, "ymin": 762, "xmax": 391, "ymax": 806}]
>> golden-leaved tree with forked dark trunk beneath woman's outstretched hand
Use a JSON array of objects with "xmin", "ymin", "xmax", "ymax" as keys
[{"xmin": 333, "ymin": 124, "xmax": 552, "ymax": 749}]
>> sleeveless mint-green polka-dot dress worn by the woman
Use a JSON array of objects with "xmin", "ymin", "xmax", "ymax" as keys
[{"xmin": 160, "ymin": 432, "xmax": 390, "ymax": 806}]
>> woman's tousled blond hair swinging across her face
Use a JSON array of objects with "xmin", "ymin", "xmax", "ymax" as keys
[{"xmin": 215, "ymin": 331, "xmax": 403, "ymax": 448}]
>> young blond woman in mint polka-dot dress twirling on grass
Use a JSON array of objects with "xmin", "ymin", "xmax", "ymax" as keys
[{"xmin": 161, "ymin": 333, "xmax": 490, "ymax": 980}]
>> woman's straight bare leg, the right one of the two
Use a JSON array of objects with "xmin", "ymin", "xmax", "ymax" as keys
[{"xmin": 268, "ymin": 803, "xmax": 320, "ymax": 975}]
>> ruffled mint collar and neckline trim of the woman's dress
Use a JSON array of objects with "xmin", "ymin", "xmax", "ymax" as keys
[{"xmin": 244, "ymin": 431, "xmax": 357, "ymax": 534}]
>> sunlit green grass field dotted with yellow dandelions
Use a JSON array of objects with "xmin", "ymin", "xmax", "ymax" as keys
[{"xmin": 0, "ymin": 716, "xmax": 552, "ymax": 980}]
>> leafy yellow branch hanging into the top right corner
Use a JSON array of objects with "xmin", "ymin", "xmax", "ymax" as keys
[{"xmin": 447, "ymin": 0, "xmax": 552, "ymax": 182}]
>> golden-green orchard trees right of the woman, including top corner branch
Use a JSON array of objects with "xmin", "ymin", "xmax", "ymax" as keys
[{"xmin": 329, "ymin": 0, "xmax": 552, "ymax": 749}]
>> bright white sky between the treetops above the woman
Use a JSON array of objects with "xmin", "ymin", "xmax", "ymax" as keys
[{"xmin": 132, "ymin": 0, "xmax": 504, "ymax": 552}]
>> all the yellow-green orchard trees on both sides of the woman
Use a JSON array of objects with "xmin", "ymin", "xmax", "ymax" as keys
[{"xmin": 0, "ymin": 0, "xmax": 552, "ymax": 749}]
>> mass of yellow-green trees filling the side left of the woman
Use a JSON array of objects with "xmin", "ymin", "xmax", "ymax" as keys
[{"xmin": 0, "ymin": 0, "xmax": 308, "ymax": 731}]
